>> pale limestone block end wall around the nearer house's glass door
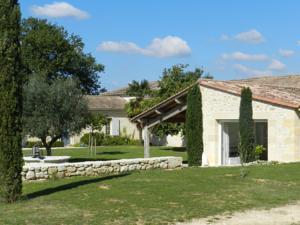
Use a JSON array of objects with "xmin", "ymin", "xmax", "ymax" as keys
[{"xmin": 200, "ymin": 86, "xmax": 300, "ymax": 165}]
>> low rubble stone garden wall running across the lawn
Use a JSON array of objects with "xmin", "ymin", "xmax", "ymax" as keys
[{"xmin": 22, "ymin": 157, "xmax": 182, "ymax": 181}]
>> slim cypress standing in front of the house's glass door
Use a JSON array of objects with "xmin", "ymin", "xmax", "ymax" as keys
[{"xmin": 239, "ymin": 87, "xmax": 255, "ymax": 163}]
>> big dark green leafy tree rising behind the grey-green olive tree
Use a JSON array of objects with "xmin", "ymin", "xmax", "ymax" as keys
[{"xmin": 21, "ymin": 18, "xmax": 104, "ymax": 94}]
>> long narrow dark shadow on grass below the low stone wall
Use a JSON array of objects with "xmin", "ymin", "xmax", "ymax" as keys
[{"xmin": 24, "ymin": 173, "xmax": 130, "ymax": 200}]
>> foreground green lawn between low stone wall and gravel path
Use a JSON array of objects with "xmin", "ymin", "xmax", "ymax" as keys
[{"xmin": 0, "ymin": 163, "xmax": 300, "ymax": 225}]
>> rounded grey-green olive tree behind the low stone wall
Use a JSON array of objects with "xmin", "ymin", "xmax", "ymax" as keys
[{"xmin": 23, "ymin": 76, "xmax": 88, "ymax": 155}]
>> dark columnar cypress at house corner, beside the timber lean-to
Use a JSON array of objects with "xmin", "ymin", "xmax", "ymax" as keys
[{"xmin": 186, "ymin": 84, "xmax": 203, "ymax": 166}]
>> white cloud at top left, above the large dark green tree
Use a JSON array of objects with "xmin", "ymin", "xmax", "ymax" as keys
[{"xmin": 31, "ymin": 2, "xmax": 90, "ymax": 19}]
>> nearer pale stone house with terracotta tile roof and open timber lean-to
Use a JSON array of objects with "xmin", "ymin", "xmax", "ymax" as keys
[{"xmin": 132, "ymin": 75, "xmax": 300, "ymax": 166}]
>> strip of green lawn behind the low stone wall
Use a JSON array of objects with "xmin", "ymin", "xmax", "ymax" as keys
[{"xmin": 23, "ymin": 146, "xmax": 187, "ymax": 162}]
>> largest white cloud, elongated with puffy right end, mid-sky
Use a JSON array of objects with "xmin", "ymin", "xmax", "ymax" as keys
[{"xmin": 97, "ymin": 36, "xmax": 191, "ymax": 58}]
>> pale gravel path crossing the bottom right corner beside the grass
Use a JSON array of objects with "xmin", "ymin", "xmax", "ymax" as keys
[{"xmin": 177, "ymin": 202, "xmax": 300, "ymax": 225}]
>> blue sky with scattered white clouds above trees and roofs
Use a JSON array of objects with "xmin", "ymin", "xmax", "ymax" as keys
[{"xmin": 20, "ymin": 0, "xmax": 300, "ymax": 90}]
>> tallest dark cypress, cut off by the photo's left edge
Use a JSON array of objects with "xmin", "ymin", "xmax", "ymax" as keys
[{"xmin": 0, "ymin": 0, "xmax": 23, "ymax": 202}]
